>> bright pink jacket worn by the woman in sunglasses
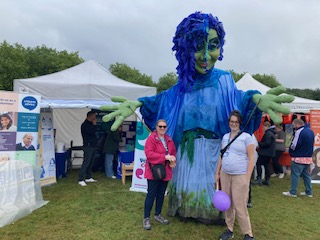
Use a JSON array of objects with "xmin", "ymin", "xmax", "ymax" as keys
[{"xmin": 144, "ymin": 131, "xmax": 176, "ymax": 181}]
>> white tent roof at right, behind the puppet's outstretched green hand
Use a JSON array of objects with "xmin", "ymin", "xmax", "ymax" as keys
[{"xmin": 236, "ymin": 73, "xmax": 320, "ymax": 113}]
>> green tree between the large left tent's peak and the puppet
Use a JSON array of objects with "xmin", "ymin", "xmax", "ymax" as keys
[{"xmin": 109, "ymin": 63, "xmax": 156, "ymax": 87}]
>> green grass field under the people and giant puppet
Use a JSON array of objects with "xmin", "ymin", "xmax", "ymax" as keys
[{"xmin": 0, "ymin": 170, "xmax": 320, "ymax": 240}]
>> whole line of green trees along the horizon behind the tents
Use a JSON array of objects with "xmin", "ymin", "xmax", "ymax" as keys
[{"xmin": 0, "ymin": 41, "xmax": 320, "ymax": 100}]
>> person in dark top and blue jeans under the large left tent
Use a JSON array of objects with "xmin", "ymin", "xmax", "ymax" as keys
[{"xmin": 102, "ymin": 125, "xmax": 122, "ymax": 179}]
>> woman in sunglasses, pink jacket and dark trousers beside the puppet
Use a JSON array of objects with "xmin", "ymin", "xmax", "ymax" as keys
[{"xmin": 143, "ymin": 119, "xmax": 176, "ymax": 230}]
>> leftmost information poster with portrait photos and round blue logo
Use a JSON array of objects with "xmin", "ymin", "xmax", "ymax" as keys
[{"xmin": 0, "ymin": 91, "xmax": 40, "ymax": 166}]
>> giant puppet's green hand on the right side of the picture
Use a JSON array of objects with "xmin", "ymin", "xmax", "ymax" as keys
[{"xmin": 253, "ymin": 85, "xmax": 294, "ymax": 124}]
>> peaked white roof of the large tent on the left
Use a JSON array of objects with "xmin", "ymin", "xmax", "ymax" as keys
[{"xmin": 14, "ymin": 60, "xmax": 156, "ymax": 101}]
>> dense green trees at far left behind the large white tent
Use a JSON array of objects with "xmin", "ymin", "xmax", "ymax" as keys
[{"xmin": 0, "ymin": 41, "xmax": 84, "ymax": 91}]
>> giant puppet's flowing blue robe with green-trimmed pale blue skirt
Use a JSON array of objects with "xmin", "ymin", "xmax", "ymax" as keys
[{"xmin": 138, "ymin": 68, "xmax": 261, "ymax": 220}]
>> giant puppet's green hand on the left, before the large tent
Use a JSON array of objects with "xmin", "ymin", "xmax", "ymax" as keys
[{"xmin": 100, "ymin": 96, "xmax": 142, "ymax": 131}]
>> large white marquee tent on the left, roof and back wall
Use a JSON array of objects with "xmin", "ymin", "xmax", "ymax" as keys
[{"xmin": 14, "ymin": 60, "xmax": 156, "ymax": 145}]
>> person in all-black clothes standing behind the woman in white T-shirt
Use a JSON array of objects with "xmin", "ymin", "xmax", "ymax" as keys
[{"xmin": 253, "ymin": 121, "xmax": 276, "ymax": 186}]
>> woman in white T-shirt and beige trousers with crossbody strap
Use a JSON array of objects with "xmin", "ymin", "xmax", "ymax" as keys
[{"xmin": 215, "ymin": 110, "xmax": 255, "ymax": 240}]
